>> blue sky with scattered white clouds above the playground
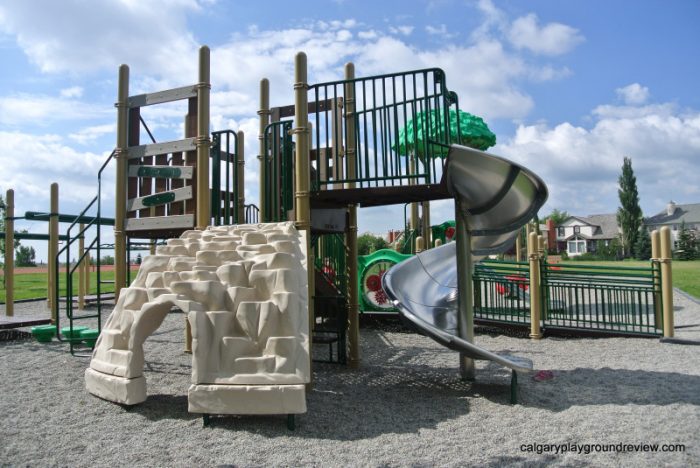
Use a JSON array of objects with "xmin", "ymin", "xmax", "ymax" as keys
[{"xmin": 0, "ymin": 0, "xmax": 700, "ymax": 257}]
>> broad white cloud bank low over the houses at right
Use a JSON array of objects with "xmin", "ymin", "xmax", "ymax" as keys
[{"xmin": 494, "ymin": 99, "xmax": 700, "ymax": 215}]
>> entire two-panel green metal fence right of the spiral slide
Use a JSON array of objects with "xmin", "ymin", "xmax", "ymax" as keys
[{"xmin": 474, "ymin": 260, "xmax": 663, "ymax": 336}]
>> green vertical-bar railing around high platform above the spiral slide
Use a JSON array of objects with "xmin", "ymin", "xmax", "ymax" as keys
[{"xmin": 309, "ymin": 68, "xmax": 457, "ymax": 191}]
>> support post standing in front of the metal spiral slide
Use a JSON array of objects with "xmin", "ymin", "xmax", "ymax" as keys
[{"xmin": 455, "ymin": 198, "xmax": 476, "ymax": 380}]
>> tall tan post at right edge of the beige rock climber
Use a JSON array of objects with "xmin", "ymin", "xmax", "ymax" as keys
[{"xmin": 292, "ymin": 52, "xmax": 316, "ymax": 374}]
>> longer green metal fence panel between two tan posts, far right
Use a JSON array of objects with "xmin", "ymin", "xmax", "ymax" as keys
[{"xmin": 542, "ymin": 263, "xmax": 663, "ymax": 335}]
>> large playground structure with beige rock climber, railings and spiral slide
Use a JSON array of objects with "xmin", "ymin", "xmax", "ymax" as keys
[{"xmin": 0, "ymin": 47, "xmax": 672, "ymax": 426}]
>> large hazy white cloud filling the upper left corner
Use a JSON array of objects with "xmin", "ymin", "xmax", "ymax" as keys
[{"xmin": 0, "ymin": 0, "xmax": 201, "ymax": 73}]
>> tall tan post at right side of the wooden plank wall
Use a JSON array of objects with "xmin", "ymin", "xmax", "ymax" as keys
[{"xmin": 195, "ymin": 46, "xmax": 211, "ymax": 231}]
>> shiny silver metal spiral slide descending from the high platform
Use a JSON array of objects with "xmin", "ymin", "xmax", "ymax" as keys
[{"xmin": 382, "ymin": 145, "xmax": 547, "ymax": 372}]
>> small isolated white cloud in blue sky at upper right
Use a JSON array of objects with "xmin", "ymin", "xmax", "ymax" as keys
[{"xmin": 508, "ymin": 13, "xmax": 584, "ymax": 55}]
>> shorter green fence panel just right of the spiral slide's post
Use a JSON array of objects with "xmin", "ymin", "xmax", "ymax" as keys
[{"xmin": 474, "ymin": 260, "xmax": 530, "ymax": 324}]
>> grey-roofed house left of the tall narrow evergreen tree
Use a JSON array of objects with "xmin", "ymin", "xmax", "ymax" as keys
[{"xmin": 555, "ymin": 214, "xmax": 621, "ymax": 257}]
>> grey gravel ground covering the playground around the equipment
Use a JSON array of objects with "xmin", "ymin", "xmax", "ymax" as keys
[{"xmin": 0, "ymin": 294, "xmax": 700, "ymax": 467}]
